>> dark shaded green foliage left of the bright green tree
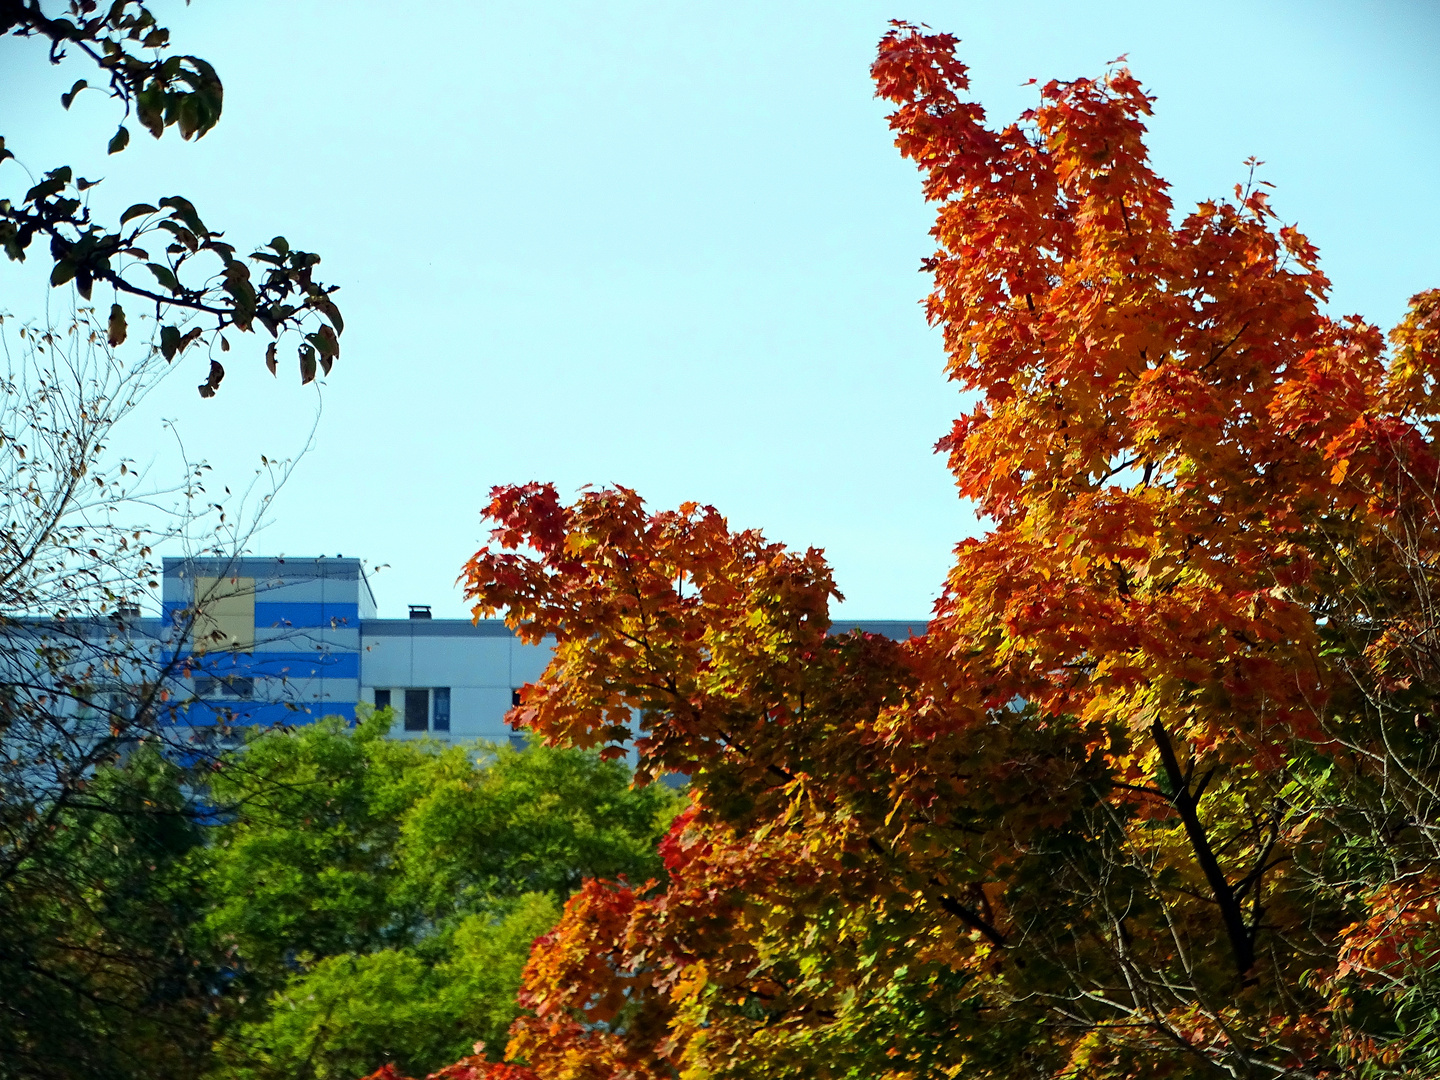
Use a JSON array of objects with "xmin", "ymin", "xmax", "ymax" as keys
[{"xmin": 0, "ymin": 746, "xmax": 223, "ymax": 1080}]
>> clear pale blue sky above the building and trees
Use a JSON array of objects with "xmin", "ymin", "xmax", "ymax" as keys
[{"xmin": 0, "ymin": 0, "xmax": 1440, "ymax": 619}]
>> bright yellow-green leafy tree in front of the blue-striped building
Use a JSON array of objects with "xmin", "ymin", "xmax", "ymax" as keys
[{"xmin": 204, "ymin": 711, "xmax": 678, "ymax": 1080}]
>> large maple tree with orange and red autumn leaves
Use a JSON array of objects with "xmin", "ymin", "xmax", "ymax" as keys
[{"xmin": 368, "ymin": 24, "xmax": 1440, "ymax": 1080}]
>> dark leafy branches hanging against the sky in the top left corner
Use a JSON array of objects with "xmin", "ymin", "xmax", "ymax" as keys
[{"xmin": 0, "ymin": 0, "xmax": 344, "ymax": 397}]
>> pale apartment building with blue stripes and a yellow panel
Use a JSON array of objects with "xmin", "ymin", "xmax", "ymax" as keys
[{"xmin": 161, "ymin": 556, "xmax": 924, "ymax": 742}]
